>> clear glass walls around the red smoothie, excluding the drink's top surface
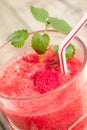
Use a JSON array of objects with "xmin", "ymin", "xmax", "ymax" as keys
[{"xmin": 0, "ymin": 30, "xmax": 87, "ymax": 130}]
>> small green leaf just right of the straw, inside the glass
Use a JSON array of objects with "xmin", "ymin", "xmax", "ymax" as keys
[{"xmin": 65, "ymin": 44, "xmax": 76, "ymax": 60}]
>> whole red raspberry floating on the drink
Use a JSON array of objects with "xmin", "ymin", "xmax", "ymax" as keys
[{"xmin": 34, "ymin": 69, "xmax": 58, "ymax": 94}]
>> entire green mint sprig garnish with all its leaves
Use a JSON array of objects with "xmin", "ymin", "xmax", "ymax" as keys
[{"xmin": 8, "ymin": 6, "xmax": 75, "ymax": 59}]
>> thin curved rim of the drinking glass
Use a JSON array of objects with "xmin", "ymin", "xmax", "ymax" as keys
[{"xmin": 0, "ymin": 30, "xmax": 87, "ymax": 100}]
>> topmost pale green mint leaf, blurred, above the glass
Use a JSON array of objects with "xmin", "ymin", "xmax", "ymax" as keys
[{"xmin": 30, "ymin": 6, "xmax": 49, "ymax": 23}]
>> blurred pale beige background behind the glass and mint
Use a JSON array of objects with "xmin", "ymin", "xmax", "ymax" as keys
[{"xmin": 0, "ymin": 0, "xmax": 87, "ymax": 130}]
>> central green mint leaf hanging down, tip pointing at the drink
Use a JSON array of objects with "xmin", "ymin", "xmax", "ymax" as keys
[{"xmin": 31, "ymin": 33, "xmax": 50, "ymax": 54}]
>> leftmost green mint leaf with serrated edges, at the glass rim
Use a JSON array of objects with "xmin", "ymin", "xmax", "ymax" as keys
[{"xmin": 8, "ymin": 30, "xmax": 29, "ymax": 48}]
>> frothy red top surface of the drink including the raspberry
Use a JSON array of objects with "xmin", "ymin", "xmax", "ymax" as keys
[{"xmin": 0, "ymin": 50, "xmax": 82, "ymax": 97}]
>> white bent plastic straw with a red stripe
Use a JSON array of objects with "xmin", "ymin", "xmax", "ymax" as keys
[{"xmin": 59, "ymin": 14, "xmax": 87, "ymax": 74}]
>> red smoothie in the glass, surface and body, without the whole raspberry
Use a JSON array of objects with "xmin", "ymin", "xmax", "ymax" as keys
[{"xmin": 0, "ymin": 50, "xmax": 82, "ymax": 130}]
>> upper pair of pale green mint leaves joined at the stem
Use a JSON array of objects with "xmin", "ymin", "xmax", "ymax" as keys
[{"xmin": 30, "ymin": 6, "xmax": 72, "ymax": 33}]
